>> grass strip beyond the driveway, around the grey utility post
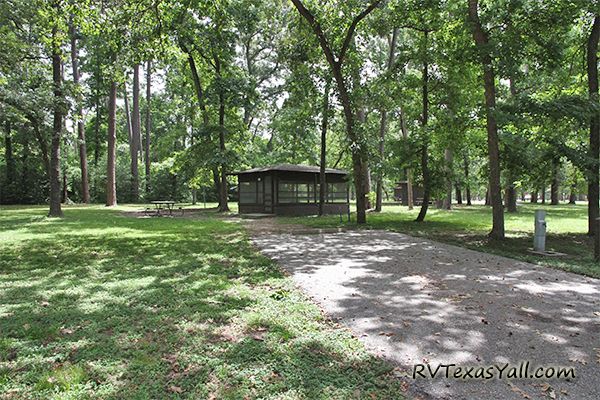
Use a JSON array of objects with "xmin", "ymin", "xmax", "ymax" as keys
[{"xmin": 279, "ymin": 204, "xmax": 600, "ymax": 278}]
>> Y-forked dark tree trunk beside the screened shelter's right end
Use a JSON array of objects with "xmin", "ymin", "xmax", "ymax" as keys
[{"xmin": 292, "ymin": 0, "xmax": 381, "ymax": 223}]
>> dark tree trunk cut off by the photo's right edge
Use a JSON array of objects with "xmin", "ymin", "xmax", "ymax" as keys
[{"xmin": 587, "ymin": 15, "xmax": 600, "ymax": 235}]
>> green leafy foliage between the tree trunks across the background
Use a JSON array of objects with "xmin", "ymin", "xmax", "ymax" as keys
[{"xmin": 0, "ymin": 0, "xmax": 599, "ymax": 231}]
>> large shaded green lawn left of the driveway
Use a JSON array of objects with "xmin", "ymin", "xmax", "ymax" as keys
[{"xmin": 0, "ymin": 206, "xmax": 402, "ymax": 399}]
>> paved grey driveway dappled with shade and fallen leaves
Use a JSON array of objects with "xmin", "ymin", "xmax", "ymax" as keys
[{"xmin": 253, "ymin": 231, "xmax": 600, "ymax": 400}]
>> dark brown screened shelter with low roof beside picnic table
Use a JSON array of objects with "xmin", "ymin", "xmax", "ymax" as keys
[{"xmin": 231, "ymin": 164, "xmax": 350, "ymax": 215}]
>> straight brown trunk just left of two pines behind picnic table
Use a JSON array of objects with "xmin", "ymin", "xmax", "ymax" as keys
[{"xmin": 106, "ymin": 81, "xmax": 117, "ymax": 207}]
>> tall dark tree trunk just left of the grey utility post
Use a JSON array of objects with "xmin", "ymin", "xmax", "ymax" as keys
[{"xmin": 468, "ymin": 0, "xmax": 504, "ymax": 239}]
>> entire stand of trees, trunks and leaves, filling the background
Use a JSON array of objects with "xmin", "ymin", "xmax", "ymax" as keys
[{"xmin": 0, "ymin": 0, "xmax": 600, "ymax": 238}]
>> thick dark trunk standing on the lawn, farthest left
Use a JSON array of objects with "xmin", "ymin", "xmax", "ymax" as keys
[{"xmin": 48, "ymin": 20, "xmax": 64, "ymax": 217}]
